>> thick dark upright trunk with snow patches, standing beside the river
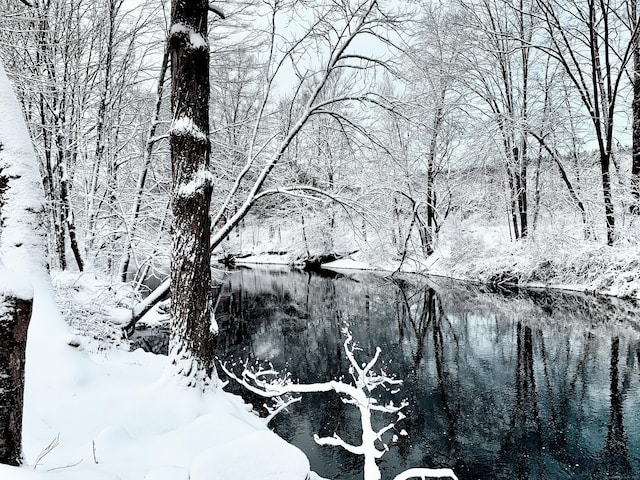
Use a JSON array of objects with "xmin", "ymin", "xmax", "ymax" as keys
[{"xmin": 169, "ymin": 0, "xmax": 217, "ymax": 386}]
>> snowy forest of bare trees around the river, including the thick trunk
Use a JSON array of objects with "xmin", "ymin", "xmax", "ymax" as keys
[{"xmin": 0, "ymin": 0, "xmax": 640, "ymax": 480}]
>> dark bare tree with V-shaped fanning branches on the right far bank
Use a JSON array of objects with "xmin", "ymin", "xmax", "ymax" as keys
[{"xmin": 534, "ymin": 0, "xmax": 638, "ymax": 245}]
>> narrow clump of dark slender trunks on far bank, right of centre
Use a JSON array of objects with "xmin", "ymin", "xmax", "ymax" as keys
[{"xmin": 461, "ymin": 0, "xmax": 535, "ymax": 239}]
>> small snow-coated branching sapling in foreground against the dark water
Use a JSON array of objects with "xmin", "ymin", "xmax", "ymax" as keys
[{"xmin": 220, "ymin": 327, "xmax": 457, "ymax": 480}]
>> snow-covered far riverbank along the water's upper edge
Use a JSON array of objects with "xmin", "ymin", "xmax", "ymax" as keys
[{"xmin": 229, "ymin": 231, "xmax": 640, "ymax": 300}]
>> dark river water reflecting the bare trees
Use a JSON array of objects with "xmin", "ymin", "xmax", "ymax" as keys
[{"xmin": 134, "ymin": 269, "xmax": 640, "ymax": 480}]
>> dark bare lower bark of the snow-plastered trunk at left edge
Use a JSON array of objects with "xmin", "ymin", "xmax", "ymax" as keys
[{"xmin": 0, "ymin": 294, "xmax": 33, "ymax": 465}]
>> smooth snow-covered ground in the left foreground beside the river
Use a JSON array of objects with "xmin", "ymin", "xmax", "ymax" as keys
[{"xmin": 0, "ymin": 275, "xmax": 316, "ymax": 480}]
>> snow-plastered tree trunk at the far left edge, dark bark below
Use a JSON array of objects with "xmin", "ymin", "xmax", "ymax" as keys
[{"xmin": 0, "ymin": 60, "xmax": 47, "ymax": 465}]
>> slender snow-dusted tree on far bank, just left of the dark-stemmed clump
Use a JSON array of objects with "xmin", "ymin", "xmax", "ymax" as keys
[{"xmin": 382, "ymin": 3, "xmax": 463, "ymax": 259}]
